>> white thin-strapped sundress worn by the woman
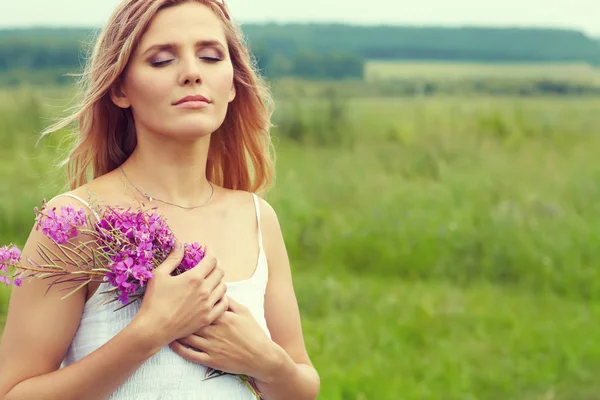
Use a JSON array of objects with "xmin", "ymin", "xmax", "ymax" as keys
[{"xmin": 56, "ymin": 194, "xmax": 270, "ymax": 400}]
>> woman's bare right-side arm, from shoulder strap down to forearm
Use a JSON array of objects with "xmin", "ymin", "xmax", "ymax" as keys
[{"xmin": 252, "ymin": 200, "xmax": 320, "ymax": 400}]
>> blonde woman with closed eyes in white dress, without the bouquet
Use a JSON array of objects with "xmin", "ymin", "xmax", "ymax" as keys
[{"xmin": 0, "ymin": 0, "xmax": 320, "ymax": 400}]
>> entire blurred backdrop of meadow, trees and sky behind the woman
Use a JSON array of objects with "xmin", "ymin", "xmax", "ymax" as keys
[{"xmin": 0, "ymin": 0, "xmax": 600, "ymax": 400}]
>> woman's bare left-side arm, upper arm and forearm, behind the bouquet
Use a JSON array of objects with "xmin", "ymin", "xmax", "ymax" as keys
[{"xmin": 0, "ymin": 198, "xmax": 160, "ymax": 400}]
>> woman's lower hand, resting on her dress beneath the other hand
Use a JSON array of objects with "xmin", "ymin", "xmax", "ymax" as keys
[{"xmin": 169, "ymin": 298, "xmax": 279, "ymax": 381}]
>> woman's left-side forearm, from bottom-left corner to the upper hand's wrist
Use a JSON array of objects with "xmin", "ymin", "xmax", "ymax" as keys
[{"xmin": 5, "ymin": 319, "xmax": 162, "ymax": 400}]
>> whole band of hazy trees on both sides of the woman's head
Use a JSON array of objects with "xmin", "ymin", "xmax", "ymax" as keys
[{"xmin": 0, "ymin": 23, "xmax": 600, "ymax": 79}]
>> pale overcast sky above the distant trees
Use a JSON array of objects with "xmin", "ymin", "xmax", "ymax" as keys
[{"xmin": 0, "ymin": 0, "xmax": 600, "ymax": 36}]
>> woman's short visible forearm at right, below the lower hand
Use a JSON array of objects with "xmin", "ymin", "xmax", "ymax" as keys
[{"xmin": 256, "ymin": 346, "xmax": 321, "ymax": 400}]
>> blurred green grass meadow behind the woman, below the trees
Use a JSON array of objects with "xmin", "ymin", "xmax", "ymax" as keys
[{"xmin": 0, "ymin": 76, "xmax": 600, "ymax": 400}]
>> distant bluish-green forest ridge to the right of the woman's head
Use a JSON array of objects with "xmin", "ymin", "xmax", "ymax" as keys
[{"xmin": 244, "ymin": 24, "xmax": 600, "ymax": 64}]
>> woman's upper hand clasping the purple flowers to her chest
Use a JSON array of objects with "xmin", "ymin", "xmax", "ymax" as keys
[{"xmin": 136, "ymin": 244, "xmax": 229, "ymax": 347}]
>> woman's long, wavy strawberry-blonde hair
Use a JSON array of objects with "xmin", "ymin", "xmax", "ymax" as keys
[{"xmin": 41, "ymin": 0, "xmax": 274, "ymax": 192}]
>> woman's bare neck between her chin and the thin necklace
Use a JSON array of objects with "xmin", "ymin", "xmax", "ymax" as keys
[{"xmin": 122, "ymin": 135, "xmax": 212, "ymax": 207}]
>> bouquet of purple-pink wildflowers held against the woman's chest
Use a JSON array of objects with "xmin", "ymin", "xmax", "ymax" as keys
[{"xmin": 0, "ymin": 200, "xmax": 260, "ymax": 398}]
